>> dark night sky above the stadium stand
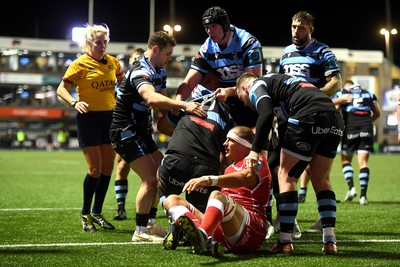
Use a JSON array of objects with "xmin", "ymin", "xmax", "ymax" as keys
[{"xmin": 0, "ymin": 0, "xmax": 400, "ymax": 65}]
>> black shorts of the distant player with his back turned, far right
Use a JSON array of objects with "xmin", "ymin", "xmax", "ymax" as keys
[{"xmin": 342, "ymin": 125, "xmax": 374, "ymax": 156}]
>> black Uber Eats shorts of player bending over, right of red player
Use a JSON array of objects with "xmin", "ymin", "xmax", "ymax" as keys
[{"xmin": 282, "ymin": 111, "xmax": 343, "ymax": 161}]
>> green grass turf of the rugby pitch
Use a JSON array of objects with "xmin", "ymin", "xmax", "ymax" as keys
[{"xmin": 0, "ymin": 150, "xmax": 400, "ymax": 267}]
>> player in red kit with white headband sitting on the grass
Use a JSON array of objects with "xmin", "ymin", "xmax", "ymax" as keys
[{"xmin": 163, "ymin": 126, "xmax": 271, "ymax": 256}]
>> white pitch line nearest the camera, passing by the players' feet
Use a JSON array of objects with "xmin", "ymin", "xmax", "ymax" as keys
[{"xmin": 0, "ymin": 239, "xmax": 400, "ymax": 249}]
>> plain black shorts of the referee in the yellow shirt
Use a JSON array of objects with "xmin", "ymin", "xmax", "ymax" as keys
[{"xmin": 76, "ymin": 110, "xmax": 112, "ymax": 147}]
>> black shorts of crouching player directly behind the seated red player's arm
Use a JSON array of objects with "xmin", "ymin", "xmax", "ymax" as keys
[{"xmin": 158, "ymin": 151, "xmax": 220, "ymax": 212}]
